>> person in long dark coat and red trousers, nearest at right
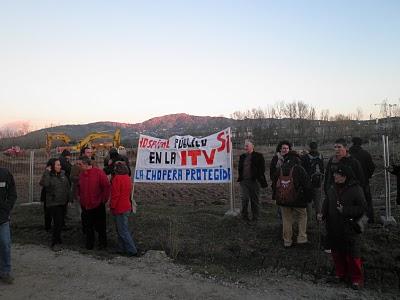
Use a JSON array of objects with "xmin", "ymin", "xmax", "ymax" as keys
[{"xmin": 318, "ymin": 164, "xmax": 367, "ymax": 289}]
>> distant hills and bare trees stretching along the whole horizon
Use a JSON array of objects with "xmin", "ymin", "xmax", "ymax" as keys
[{"xmin": 0, "ymin": 113, "xmax": 394, "ymax": 150}]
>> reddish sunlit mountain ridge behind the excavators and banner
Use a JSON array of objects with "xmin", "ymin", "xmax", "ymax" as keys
[{"xmin": 0, "ymin": 113, "xmax": 236, "ymax": 149}]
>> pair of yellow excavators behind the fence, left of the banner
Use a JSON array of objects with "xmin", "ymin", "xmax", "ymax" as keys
[{"xmin": 46, "ymin": 128, "xmax": 121, "ymax": 153}]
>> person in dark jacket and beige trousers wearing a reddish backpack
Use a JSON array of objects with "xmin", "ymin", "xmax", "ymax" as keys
[{"xmin": 273, "ymin": 151, "xmax": 311, "ymax": 248}]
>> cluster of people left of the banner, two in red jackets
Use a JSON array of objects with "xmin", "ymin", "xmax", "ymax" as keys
[{"xmin": 40, "ymin": 146, "xmax": 137, "ymax": 256}]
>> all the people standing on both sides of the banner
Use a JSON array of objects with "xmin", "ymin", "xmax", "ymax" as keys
[{"xmin": 0, "ymin": 138, "xmax": 400, "ymax": 289}]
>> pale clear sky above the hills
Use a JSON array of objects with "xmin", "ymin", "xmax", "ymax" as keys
[{"xmin": 0, "ymin": 0, "xmax": 400, "ymax": 127}]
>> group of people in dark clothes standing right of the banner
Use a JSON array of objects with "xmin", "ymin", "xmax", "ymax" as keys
[{"xmin": 238, "ymin": 137, "xmax": 375, "ymax": 289}]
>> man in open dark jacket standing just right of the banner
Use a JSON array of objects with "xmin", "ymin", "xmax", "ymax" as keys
[{"xmin": 238, "ymin": 140, "xmax": 268, "ymax": 222}]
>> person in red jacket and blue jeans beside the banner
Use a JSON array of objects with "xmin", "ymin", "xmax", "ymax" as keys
[{"xmin": 110, "ymin": 161, "xmax": 137, "ymax": 256}]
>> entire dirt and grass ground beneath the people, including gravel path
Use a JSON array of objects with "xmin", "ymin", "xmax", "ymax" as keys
[{"xmin": 6, "ymin": 197, "xmax": 400, "ymax": 299}]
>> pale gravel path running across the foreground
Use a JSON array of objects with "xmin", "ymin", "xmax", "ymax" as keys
[{"xmin": 0, "ymin": 245, "xmax": 395, "ymax": 300}]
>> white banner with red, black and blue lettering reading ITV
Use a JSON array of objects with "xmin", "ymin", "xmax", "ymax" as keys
[{"xmin": 134, "ymin": 128, "xmax": 232, "ymax": 183}]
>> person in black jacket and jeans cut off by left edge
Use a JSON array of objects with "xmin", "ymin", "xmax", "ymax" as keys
[{"xmin": 0, "ymin": 168, "xmax": 17, "ymax": 284}]
